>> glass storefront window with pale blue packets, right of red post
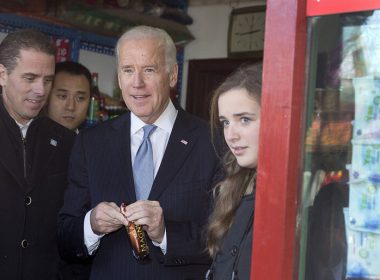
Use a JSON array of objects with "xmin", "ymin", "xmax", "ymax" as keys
[{"xmin": 299, "ymin": 11, "xmax": 380, "ymax": 280}]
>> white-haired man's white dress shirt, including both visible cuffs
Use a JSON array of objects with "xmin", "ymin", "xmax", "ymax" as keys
[{"xmin": 84, "ymin": 101, "xmax": 178, "ymax": 255}]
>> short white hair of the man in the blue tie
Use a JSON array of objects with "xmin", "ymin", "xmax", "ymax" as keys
[{"xmin": 116, "ymin": 25, "xmax": 177, "ymax": 72}]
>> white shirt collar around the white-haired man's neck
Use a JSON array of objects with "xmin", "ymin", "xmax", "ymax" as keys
[{"xmin": 131, "ymin": 100, "xmax": 178, "ymax": 135}]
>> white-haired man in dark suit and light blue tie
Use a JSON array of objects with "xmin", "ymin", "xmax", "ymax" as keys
[{"xmin": 58, "ymin": 26, "xmax": 218, "ymax": 280}]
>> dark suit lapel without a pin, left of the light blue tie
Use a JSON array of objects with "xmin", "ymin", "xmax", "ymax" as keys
[{"xmin": 107, "ymin": 113, "xmax": 136, "ymax": 203}]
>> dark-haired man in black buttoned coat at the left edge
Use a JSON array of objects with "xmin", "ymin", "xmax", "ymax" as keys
[{"xmin": 0, "ymin": 27, "xmax": 75, "ymax": 280}]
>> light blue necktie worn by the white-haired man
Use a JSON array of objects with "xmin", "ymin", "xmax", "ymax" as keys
[{"xmin": 133, "ymin": 124, "xmax": 157, "ymax": 200}]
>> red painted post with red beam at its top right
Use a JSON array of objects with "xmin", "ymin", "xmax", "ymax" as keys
[{"xmin": 251, "ymin": 0, "xmax": 380, "ymax": 280}]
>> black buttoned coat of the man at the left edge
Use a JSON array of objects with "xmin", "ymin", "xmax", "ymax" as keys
[{"xmin": 0, "ymin": 94, "xmax": 75, "ymax": 280}]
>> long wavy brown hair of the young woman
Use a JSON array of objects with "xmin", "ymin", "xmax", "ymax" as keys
[{"xmin": 206, "ymin": 63, "xmax": 262, "ymax": 257}]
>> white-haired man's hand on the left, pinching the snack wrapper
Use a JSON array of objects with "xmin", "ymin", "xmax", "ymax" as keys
[{"xmin": 90, "ymin": 202, "xmax": 128, "ymax": 235}]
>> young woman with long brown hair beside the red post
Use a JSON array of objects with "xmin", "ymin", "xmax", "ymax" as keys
[{"xmin": 206, "ymin": 64, "xmax": 262, "ymax": 280}]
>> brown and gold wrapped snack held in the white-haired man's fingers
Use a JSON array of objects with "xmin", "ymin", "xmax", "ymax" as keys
[{"xmin": 120, "ymin": 203, "xmax": 149, "ymax": 260}]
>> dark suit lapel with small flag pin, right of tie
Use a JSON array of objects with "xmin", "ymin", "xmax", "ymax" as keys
[{"xmin": 149, "ymin": 110, "xmax": 198, "ymax": 200}]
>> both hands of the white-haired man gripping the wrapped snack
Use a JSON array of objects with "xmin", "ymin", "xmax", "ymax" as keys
[{"xmin": 90, "ymin": 200, "xmax": 165, "ymax": 243}]
